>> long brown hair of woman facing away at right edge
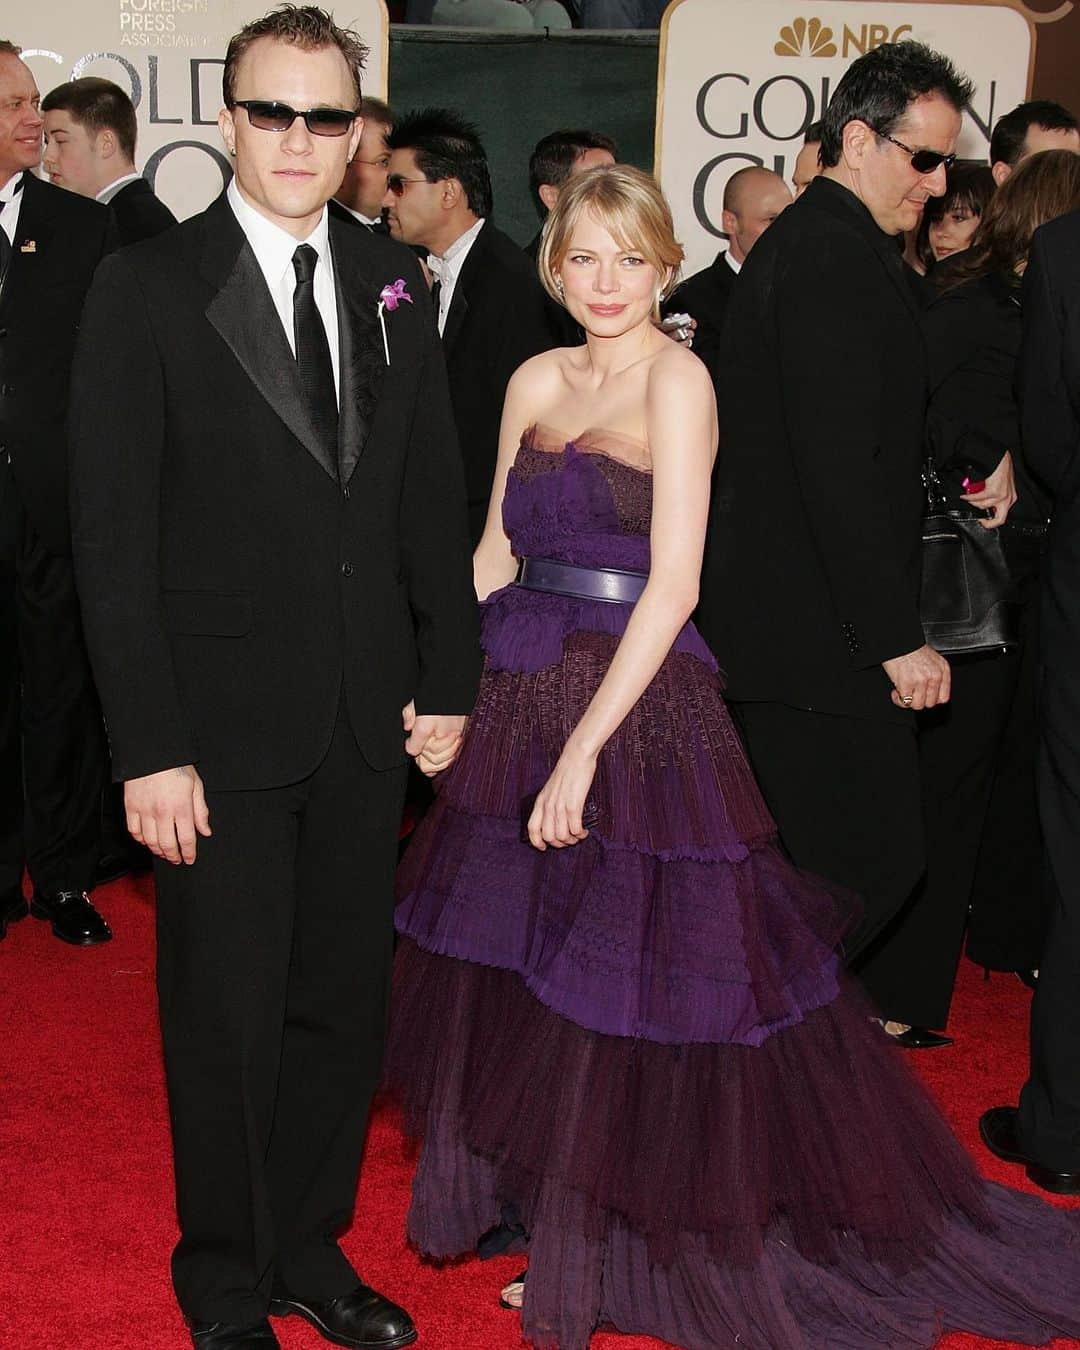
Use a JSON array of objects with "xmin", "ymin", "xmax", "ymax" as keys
[{"xmin": 942, "ymin": 150, "xmax": 1080, "ymax": 290}]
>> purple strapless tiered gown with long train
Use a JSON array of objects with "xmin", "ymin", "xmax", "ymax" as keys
[{"xmin": 387, "ymin": 432, "xmax": 1080, "ymax": 1350}]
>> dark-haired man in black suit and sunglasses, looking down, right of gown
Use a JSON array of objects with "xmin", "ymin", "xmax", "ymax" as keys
[{"xmin": 699, "ymin": 42, "xmax": 971, "ymax": 992}]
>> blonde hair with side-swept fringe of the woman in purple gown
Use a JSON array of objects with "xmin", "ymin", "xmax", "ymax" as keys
[{"xmin": 537, "ymin": 165, "xmax": 683, "ymax": 319}]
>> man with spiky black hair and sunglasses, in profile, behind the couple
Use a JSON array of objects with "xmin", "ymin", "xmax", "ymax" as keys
[{"xmin": 386, "ymin": 108, "xmax": 559, "ymax": 547}]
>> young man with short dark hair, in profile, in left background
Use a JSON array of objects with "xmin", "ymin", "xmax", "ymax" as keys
[{"xmin": 42, "ymin": 76, "xmax": 177, "ymax": 244}]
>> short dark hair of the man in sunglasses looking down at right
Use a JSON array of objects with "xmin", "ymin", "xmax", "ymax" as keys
[{"xmin": 818, "ymin": 42, "xmax": 975, "ymax": 169}]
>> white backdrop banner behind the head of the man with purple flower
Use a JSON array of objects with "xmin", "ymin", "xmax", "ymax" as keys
[{"xmin": 20, "ymin": 0, "xmax": 389, "ymax": 219}]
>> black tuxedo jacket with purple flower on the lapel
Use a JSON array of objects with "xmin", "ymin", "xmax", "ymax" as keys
[{"xmin": 72, "ymin": 196, "xmax": 479, "ymax": 788}]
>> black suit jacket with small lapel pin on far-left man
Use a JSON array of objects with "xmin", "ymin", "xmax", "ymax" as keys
[{"xmin": 0, "ymin": 173, "xmax": 117, "ymax": 555}]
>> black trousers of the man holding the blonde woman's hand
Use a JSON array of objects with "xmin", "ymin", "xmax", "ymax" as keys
[{"xmin": 155, "ymin": 707, "xmax": 405, "ymax": 1323}]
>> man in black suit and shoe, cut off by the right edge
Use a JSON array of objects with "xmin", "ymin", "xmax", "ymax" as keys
[{"xmin": 979, "ymin": 212, "xmax": 1080, "ymax": 1195}]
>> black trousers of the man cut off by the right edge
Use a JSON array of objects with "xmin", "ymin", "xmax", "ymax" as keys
[{"xmin": 1018, "ymin": 667, "xmax": 1080, "ymax": 1172}]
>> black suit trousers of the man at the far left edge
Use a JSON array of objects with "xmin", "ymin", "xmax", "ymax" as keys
[{"xmin": 0, "ymin": 451, "xmax": 108, "ymax": 894}]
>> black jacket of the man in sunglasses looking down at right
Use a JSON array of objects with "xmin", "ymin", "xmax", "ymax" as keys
[{"xmin": 699, "ymin": 178, "xmax": 926, "ymax": 720}]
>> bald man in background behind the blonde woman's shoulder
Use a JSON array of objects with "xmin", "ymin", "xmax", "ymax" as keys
[{"xmin": 663, "ymin": 166, "xmax": 792, "ymax": 381}]
